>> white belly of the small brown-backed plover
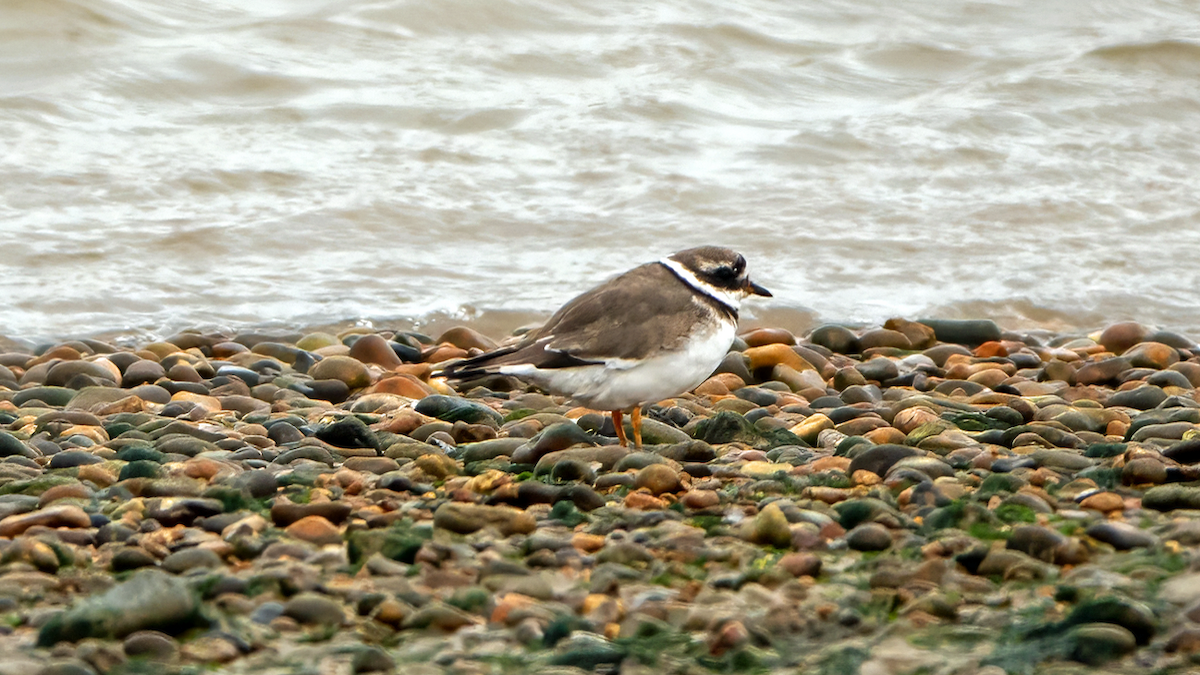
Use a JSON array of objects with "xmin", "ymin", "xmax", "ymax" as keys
[{"xmin": 500, "ymin": 321, "xmax": 737, "ymax": 411}]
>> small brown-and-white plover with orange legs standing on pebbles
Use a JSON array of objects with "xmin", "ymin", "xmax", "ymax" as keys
[{"xmin": 434, "ymin": 246, "xmax": 772, "ymax": 447}]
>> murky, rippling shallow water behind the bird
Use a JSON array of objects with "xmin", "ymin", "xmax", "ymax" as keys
[{"xmin": 0, "ymin": 0, "xmax": 1200, "ymax": 340}]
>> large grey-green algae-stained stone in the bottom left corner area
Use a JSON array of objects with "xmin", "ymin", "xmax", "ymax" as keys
[{"xmin": 37, "ymin": 569, "xmax": 203, "ymax": 647}]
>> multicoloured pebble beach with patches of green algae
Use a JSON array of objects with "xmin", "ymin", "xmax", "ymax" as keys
[{"xmin": 0, "ymin": 318, "xmax": 1200, "ymax": 675}]
